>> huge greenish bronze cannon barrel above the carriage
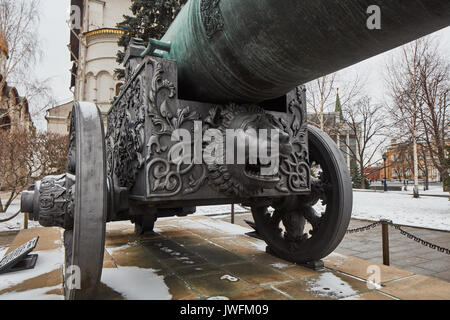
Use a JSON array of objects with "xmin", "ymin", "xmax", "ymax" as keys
[{"xmin": 162, "ymin": 0, "xmax": 450, "ymax": 103}]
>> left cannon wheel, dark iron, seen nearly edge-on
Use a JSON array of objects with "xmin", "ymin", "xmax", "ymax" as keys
[{"xmin": 64, "ymin": 102, "xmax": 107, "ymax": 300}]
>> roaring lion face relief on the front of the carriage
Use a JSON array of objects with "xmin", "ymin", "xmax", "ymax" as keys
[{"xmin": 206, "ymin": 104, "xmax": 292, "ymax": 197}]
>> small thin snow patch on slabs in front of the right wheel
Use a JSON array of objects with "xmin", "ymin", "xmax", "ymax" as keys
[{"xmin": 308, "ymin": 272, "xmax": 358, "ymax": 299}]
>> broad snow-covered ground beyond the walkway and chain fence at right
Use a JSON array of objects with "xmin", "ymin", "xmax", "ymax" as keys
[{"xmin": 352, "ymin": 191, "xmax": 450, "ymax": 231}]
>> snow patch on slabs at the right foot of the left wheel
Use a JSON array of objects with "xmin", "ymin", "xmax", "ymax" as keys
[{"xmin": 101, "ymin": 267, "xmax": 172, "ymax": 300}]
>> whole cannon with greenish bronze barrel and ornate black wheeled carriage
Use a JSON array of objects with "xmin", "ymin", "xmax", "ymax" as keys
[{"xmin": 18, "ymin": 0, "xmax": 450, "ymax": 299}]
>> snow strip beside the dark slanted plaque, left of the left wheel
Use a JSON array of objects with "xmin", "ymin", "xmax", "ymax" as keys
[{"xmin": 0, "ymin": 248, "xmax": 64, "ymax": 298}]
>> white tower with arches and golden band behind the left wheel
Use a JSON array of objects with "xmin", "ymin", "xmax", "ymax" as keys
[{"xmin": 46, "ymin": 0, "xmax": 131, "ymax": 133}]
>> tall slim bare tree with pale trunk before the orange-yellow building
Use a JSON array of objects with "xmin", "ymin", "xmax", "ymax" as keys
[{"xmin": 387, "ymin": 39, "xmax": 428, "ymax": 198}]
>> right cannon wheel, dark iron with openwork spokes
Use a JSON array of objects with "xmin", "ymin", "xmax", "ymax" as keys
[{"xmin": 252, "ymin": 126, "xmax": 353, "ymax": 263}]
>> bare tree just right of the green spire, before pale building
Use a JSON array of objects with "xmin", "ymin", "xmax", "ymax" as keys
[{"xmin": 336, "ymin": 96, "xmax": 388, "ymax": 189}]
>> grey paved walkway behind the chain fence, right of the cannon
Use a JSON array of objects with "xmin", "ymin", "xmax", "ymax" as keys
[{"xmin": 222, "ymin": 214, "xmax": 450, "ymax": 282}]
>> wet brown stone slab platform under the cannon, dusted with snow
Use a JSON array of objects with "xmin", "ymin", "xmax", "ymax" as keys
[{"xmin": 0, "ymin": 216, "xmax": 450, "ymax": 300}]
